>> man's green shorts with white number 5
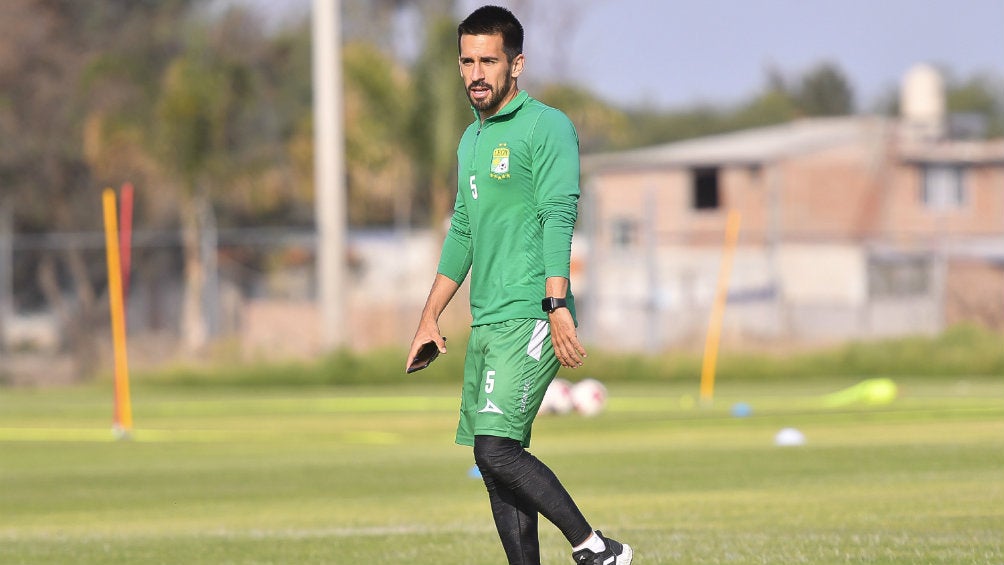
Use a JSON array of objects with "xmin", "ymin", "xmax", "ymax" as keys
[{"xmin": 457, "ymin": 319, "xmax": 560, "ymax": 448}]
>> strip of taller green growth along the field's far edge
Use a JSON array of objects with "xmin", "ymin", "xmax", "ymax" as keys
[{"xmin": 136, "ymin": 325, "xmax": 1004, "ymax": 386}]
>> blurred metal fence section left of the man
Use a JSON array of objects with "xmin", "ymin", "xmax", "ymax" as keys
[{"xmin": 0, "ymin": 220, "xmax": 459, "ymax": 378}]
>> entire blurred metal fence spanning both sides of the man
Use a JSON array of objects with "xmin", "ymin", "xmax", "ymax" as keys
[{"xmin": 0, "ymin": 217, "xmax": 1004, "ymax": 385}]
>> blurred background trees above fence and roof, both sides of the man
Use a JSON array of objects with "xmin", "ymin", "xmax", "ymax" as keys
[{"xmin": 0, "ymin": 0, "xmax": 1004, "ymax": 230}]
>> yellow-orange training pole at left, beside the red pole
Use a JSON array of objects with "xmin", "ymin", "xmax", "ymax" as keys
[{"xmin": 102, "ymin": 189, "xmax": 133, "ymax": 436}]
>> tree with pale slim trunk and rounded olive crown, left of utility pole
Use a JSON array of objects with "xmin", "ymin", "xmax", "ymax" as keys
[{"xmin": 156, "ymin": 9, "xmax": 271, "ymax": 352}]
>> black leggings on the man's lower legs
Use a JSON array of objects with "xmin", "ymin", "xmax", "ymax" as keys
[{"xmin": 474, "ymin": 436, "xmax": 592, "ymax": 565}]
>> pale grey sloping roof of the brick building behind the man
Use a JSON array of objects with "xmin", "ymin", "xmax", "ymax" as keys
[{"xmin": 582, "ymin": 112, "xmax": 887, "ymax": 172}]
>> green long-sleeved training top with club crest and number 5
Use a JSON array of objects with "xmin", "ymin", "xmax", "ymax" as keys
[{"xmin": 439, "ymin": 90, "xmax": 579, "ymax": 325}]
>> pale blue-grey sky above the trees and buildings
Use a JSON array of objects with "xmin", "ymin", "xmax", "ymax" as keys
[{"xmin": 249, "ymin": 0, "xmax": 1004, "ymax": 109}]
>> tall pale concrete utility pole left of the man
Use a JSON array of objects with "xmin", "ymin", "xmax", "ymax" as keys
[{"xmin": 311, "ymin": 0, "xmax": 348, "ymax": 349}]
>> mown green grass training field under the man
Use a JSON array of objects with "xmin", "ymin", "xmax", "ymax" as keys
[{"xmin": 0, "ymin": 375, "xmax": 1004, "ymax": 565}]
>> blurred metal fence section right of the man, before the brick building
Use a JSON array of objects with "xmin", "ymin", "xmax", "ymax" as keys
[{"xmin": 577, "ymin": 217, "xmax": 1004, "ymax": 352}]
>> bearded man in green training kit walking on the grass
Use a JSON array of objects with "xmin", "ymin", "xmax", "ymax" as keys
[{"xmin": 408, "ymin": 6, "xmax": 633, "ymax": 565}]
